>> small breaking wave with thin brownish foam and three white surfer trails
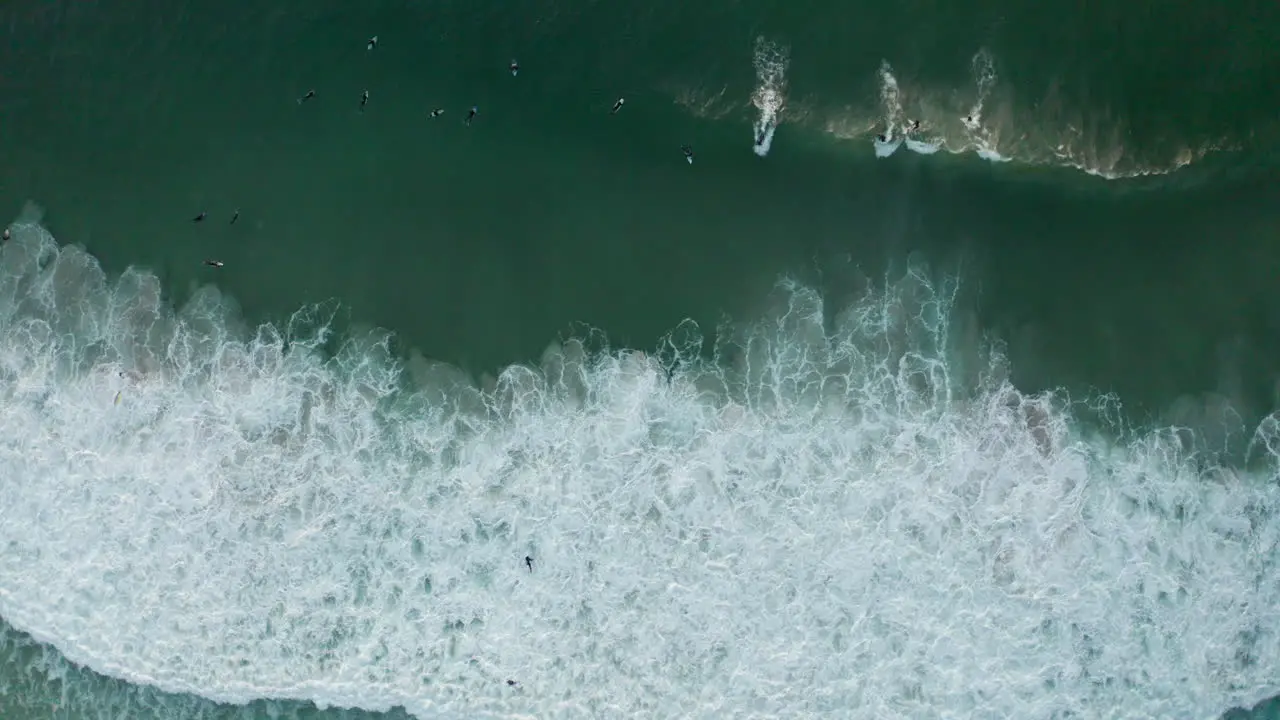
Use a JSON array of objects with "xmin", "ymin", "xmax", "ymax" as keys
[{"xmin": 664, "ymin": 44, "xmax": 1218, "ymax": 179}]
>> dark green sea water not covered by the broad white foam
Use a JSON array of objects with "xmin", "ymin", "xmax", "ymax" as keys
[{"xmin": 0, "ymin": 0, "xmax": 1280, "ymax": 717}]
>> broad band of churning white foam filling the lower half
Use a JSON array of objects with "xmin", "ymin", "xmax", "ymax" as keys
[{"xmin": 0, "ymin": 212, "xmax": 1280, "ymax": 719}]
